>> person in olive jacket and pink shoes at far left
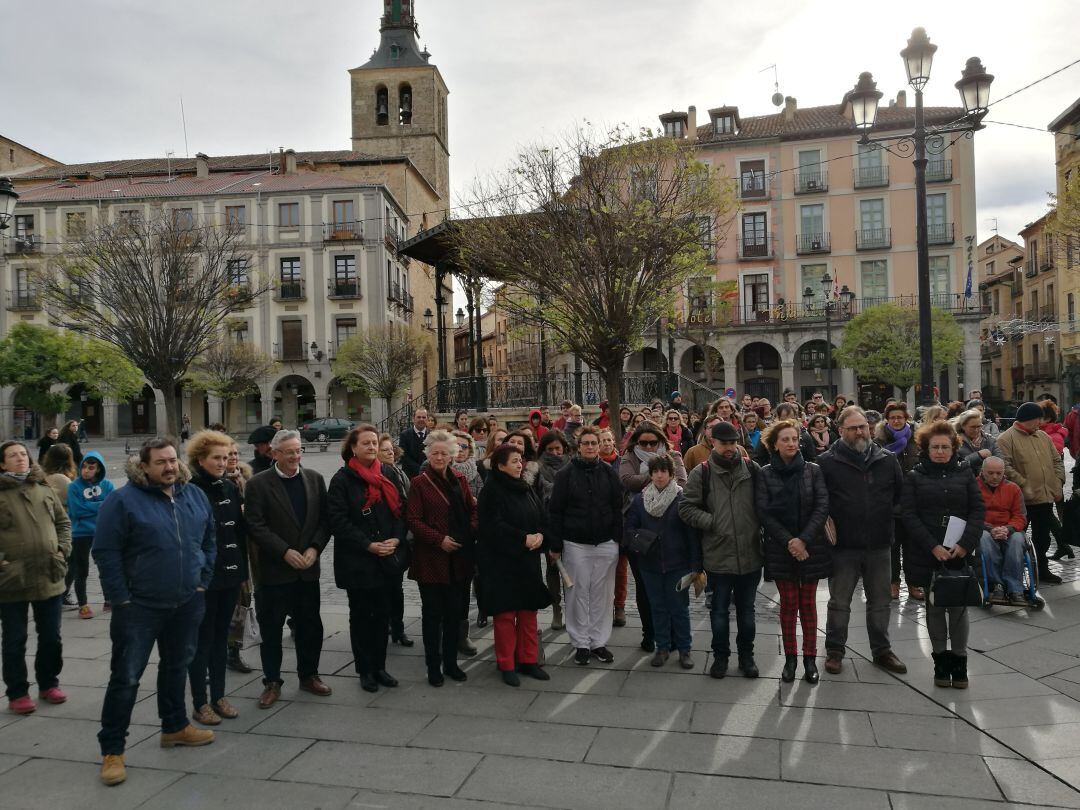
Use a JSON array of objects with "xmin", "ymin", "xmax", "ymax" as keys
[{"xmin": 0, "ymin": 442, "xmax": 71, "ymax": 714}]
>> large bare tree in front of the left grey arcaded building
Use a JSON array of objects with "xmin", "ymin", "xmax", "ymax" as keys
[{"xmin": 37, "ymin": 210, "xmax": 269, "ymax": 433}]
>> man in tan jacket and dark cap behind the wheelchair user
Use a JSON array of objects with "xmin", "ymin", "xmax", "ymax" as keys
[{"xmin": 998, "ymin": 402, "xmax": 1065, "ymax": 585}]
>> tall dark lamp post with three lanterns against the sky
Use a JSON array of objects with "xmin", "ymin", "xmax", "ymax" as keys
[{"xmin": 848, "ymin": 28, "xmax": 994, "ymax": 405}]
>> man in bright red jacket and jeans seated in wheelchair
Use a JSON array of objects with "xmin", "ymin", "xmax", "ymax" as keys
[{"xmin": 978, "ymin": 456, "xmax": 1027, "ymax": 604}]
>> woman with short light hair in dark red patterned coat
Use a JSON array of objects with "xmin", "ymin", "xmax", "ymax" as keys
[{"xmin": 406, "ymin": 430, "xmax": 476, "ymax": 686}]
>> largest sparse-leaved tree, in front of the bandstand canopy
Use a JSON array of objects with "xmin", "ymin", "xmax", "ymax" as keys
[{"xmin": 454, "ymin": 127, "xmax": 735, "ymax": 425}]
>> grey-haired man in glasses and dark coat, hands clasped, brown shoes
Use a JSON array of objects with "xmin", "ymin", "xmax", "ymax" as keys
[{"xmin": 244, "ymin": 430, "xmax": 330, "ymax": 708}]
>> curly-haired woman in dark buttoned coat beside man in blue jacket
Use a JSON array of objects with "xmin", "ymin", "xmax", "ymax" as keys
[{"xmin": 187, "ymin": 430, "xmax": 247, "ymax": 726}]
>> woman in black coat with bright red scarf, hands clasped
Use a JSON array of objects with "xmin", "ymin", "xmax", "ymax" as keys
[{"xmin": 326, "ymin": 424, "xmax": 408, "ymax": 692}]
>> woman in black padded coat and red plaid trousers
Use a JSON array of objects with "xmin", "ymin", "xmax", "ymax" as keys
[{"xmin": 754, "ymin": 419, "xmax": 833, "ymax": 684}]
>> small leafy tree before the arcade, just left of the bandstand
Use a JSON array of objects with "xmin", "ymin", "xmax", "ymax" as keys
[{"xmin": 333, "ymin": 324, "xmax": 432, "ymax": 413}]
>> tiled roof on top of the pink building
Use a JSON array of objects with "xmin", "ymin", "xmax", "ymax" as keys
[{"xmin": 698, "ymin": 105, "xmax": 963, "ymax": 144}]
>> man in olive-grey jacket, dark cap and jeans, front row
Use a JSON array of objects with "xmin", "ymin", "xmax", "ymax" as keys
[{"xmin": 678, "ymin": 422, "xmax": 765, "ymax": 678}]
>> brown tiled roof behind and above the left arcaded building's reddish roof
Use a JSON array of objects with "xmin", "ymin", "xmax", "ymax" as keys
[{"xmin": 19, "ymin": 149, "xmax": 405, "ymax": 180}]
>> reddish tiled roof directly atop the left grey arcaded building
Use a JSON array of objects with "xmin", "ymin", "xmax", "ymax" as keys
[{"xmin": 18, "ymin": 172, "xmax": 386, "ymax": 205}]
